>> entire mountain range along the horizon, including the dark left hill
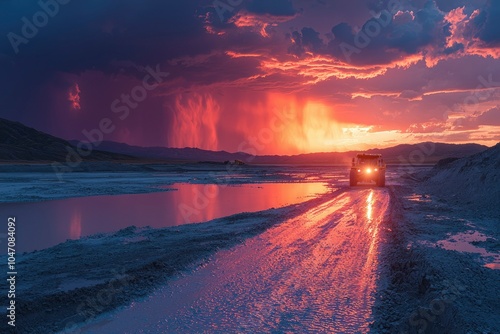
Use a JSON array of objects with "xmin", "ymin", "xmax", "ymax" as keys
[{"xmin": 0, "ymin": 118, "xmax": 487, "ymax": 164}]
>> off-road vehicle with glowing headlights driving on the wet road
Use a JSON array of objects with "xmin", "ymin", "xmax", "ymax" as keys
[{"xmin": 349, "ymin": 153, "xmax": 385, "ymax": 187}]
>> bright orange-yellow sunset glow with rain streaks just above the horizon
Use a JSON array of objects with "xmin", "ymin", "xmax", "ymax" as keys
[{"xmin": 166, "ymin": 87, "xmax": 496, "ymax": 155}]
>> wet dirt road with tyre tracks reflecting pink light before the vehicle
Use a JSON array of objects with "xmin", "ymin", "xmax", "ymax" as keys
[{"xmin": 82, "ymin": 187, "xmax": 389, "ymax": 333}]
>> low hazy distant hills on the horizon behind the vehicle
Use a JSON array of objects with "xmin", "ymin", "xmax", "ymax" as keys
[{"xmin": 88, "ymin": 141, "xmax": 488, "ymax": 164}]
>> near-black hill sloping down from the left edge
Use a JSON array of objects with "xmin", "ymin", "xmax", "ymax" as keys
[{"xmin": 0, "ymin": 118, "xmax": 137, "ymax": 162}]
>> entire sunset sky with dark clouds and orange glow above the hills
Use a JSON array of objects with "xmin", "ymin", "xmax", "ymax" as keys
[{"xmin": 0, "ymin": 0, "xmax": 500, "ymax": 154}]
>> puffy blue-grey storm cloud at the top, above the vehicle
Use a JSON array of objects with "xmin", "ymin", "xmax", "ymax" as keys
[{"xmin": 289, "ymin": 1, "xmax": 451, "ymax": 64}]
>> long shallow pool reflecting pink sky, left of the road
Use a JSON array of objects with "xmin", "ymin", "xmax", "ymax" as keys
[{"xmin": 0, "ymin": 182, "xmax": 327, "ymax": 254}]
